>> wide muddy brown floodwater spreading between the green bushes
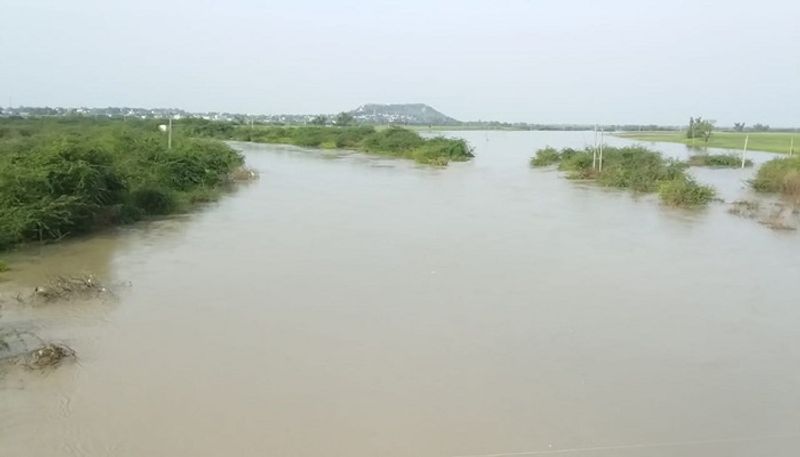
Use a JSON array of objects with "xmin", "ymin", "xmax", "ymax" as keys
[{"xmin": 0, "ymin": 132, "xmax": 800, "ymax": 457}]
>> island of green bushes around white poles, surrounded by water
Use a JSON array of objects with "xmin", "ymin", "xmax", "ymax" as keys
[{"xmin": 531, "ymin": 146, "xmax": 714, "ymax": 207}]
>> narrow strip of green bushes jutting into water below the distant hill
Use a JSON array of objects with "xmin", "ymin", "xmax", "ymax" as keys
[{"xmin": 181, "ymin": 120, "xmax": 473, "ymax": 165}]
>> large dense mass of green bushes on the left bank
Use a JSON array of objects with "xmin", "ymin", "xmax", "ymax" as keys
[{"xmin": 0, "ymin": 118, "xmax": 243, "ymax": 250}]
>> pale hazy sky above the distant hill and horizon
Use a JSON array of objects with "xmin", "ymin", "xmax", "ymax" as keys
[{"xmin": 0, "ymin": 0, "xmax": 800, "ymax": 126}]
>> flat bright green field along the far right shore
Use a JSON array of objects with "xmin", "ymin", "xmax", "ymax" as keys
[{"xmin": 615, "ymin": 131, "xmax": 800, "ymax": 153}]
